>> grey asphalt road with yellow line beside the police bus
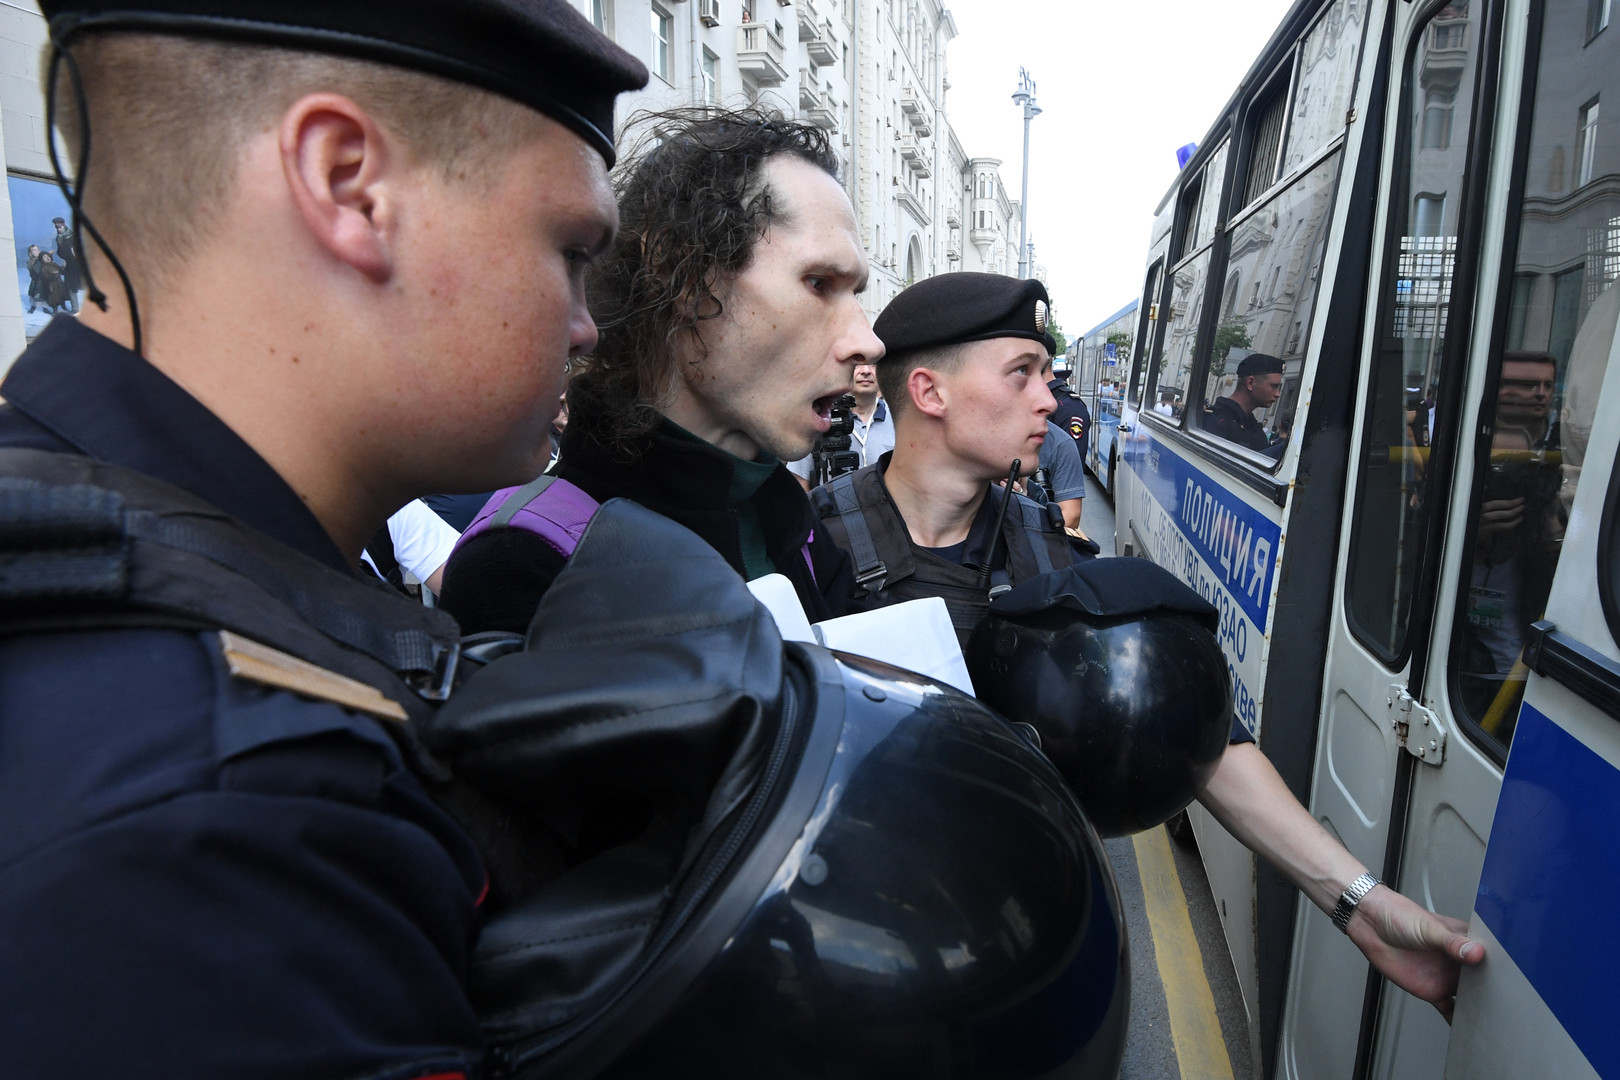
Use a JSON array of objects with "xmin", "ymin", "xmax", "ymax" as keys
[{"xmin": 1081, "ymin": 474, "xmax": 1257, "ymax": 1080}]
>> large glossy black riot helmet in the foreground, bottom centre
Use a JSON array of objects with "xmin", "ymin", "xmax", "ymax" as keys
[{"xmin": 424, "ymin": 500, "xmax": 1129, "ymax": 1078}]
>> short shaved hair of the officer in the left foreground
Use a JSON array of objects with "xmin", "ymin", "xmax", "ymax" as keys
[{"xmin": 42, "ymin": 32, "xmax": 544, "ymax": 296}]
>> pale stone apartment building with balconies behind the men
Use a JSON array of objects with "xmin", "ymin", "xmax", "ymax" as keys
[{"xmin": 0, "ymin": 0, "xmax": 1038, "ymax": 372}]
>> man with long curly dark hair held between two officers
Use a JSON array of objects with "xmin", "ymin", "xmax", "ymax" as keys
[{"xmin": 441, "ymin": 110, "xmax": 883, "ymax": 633}]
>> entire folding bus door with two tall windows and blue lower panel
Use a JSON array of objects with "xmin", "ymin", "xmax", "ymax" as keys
[{"xmin": 1286, "ymin": 0, "xmax": 1620, "ymax": 1080}]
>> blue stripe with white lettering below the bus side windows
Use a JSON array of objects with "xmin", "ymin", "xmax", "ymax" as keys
[{"xmin": 1121, "ymin": 436, "xmax": 1281, "ymax": 633}]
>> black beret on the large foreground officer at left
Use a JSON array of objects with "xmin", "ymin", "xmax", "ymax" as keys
[{"xmin": 41, "ymin": 0, "xmax": 646, "ymax": 165}]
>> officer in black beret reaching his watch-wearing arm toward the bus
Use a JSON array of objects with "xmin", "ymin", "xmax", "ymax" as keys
[{"xmin": 813, "ymin": 274, "xmax": 1484, "ymax": 1015}]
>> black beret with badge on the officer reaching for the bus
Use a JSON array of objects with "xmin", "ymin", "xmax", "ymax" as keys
[{"xmin": 872, "ymin": 272, "xmax": 1058, "ymax": 359}]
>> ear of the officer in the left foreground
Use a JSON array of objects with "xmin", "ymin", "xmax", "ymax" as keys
[{"xmin": 277, "ymin": 92, "xmax": 396, "ymax": 282}]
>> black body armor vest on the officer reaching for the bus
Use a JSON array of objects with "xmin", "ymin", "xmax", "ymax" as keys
[{"xmin": 813, "ymin": 465, "xmax": 1077, "ymax": 643}]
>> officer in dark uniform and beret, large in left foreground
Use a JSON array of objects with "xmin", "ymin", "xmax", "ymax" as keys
[{"xmin": 0, "ymin": 0, "xmax": 646, "ymax": 1077}]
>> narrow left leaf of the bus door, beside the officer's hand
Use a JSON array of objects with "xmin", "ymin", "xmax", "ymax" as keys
[{"xmin": 1278, "ymin": 0, "xmax": 1500, "ymax": 1080}]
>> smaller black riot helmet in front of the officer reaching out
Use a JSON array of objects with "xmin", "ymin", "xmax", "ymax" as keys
[{"xmin": 966, "ymin": 559, "xmax": 1233, "ymax": 836}]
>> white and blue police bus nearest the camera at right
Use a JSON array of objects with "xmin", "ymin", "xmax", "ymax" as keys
[{"xmin": 1115, "ymin": 0, "xmax": 1620, "ymax": 1080}]
